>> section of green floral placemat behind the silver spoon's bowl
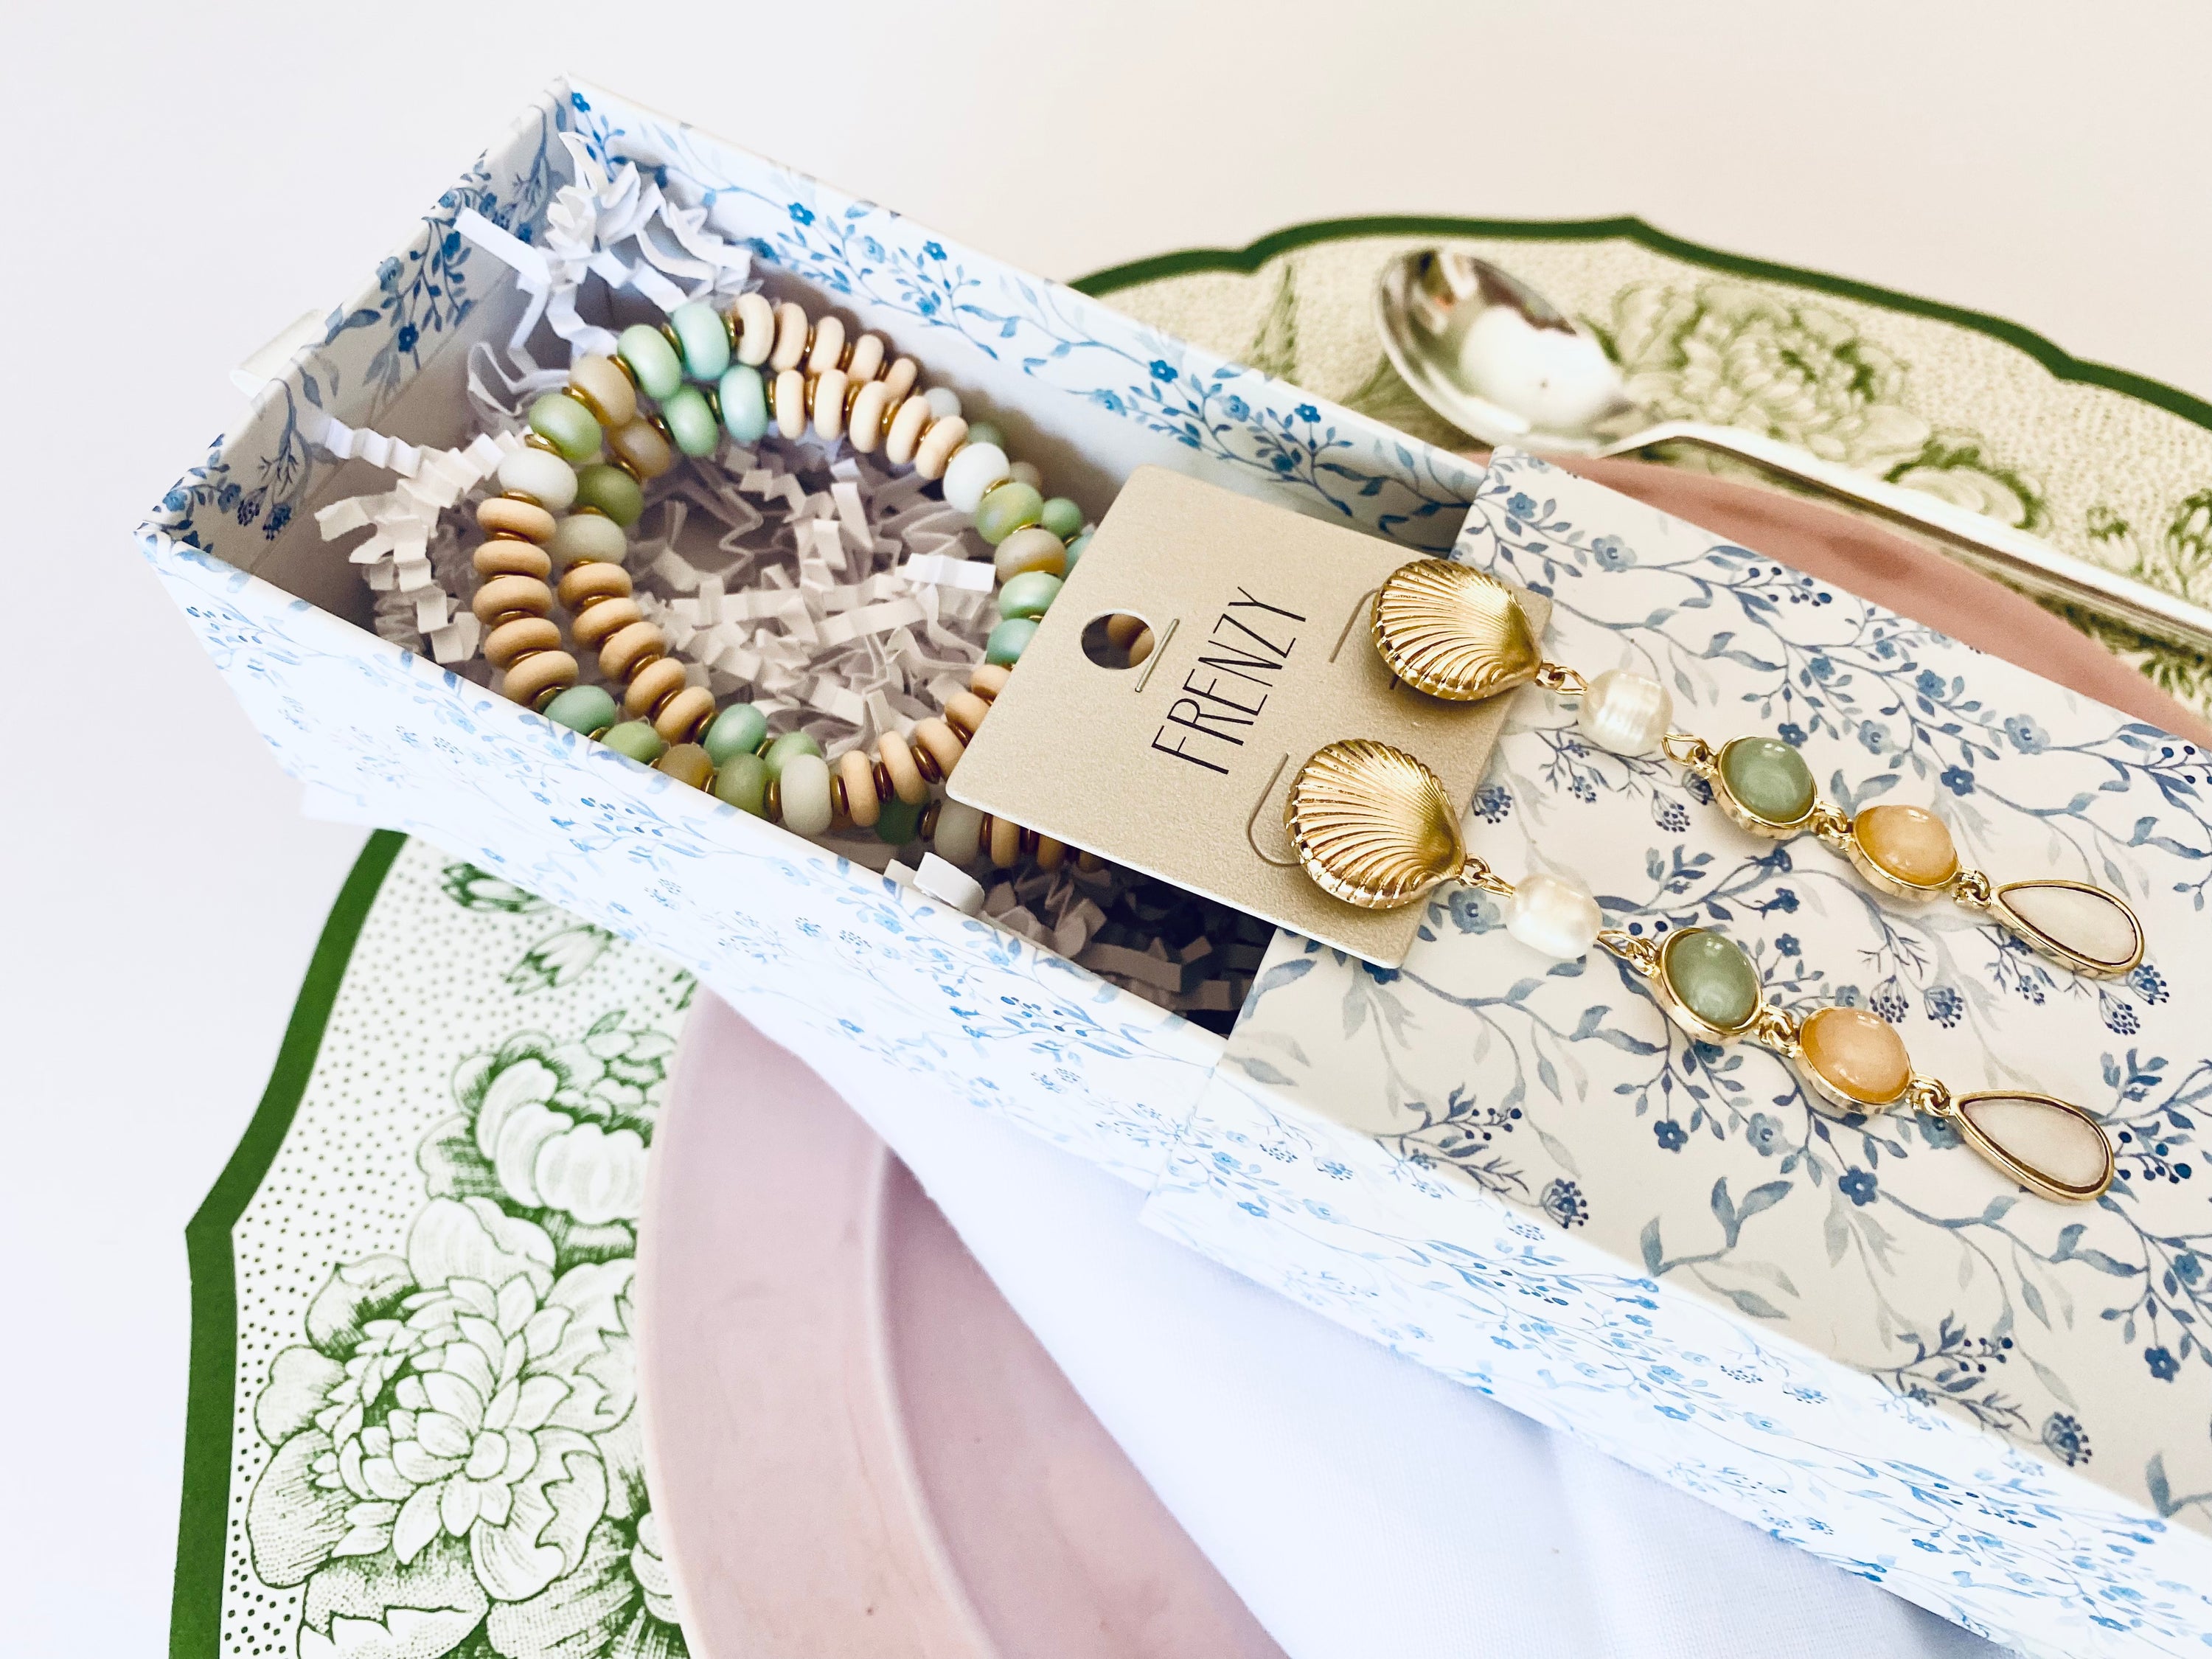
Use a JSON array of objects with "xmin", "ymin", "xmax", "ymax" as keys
[{"xmin": 1079, "ymin": 219, "xmax": 2212, "ymax": 712}]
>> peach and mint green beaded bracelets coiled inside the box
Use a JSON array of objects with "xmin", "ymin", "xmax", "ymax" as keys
[{"xmin": 460, "ymin": 294, "xmax": 1106, "ymax": 869}]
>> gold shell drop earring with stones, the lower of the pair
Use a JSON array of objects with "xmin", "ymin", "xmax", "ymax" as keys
[{"xmin": 1283, "ymin": 739, "xmax": 2112, "ymax": 1203}]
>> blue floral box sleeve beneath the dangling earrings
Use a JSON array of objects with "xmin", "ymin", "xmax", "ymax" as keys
[{"xmin": 1146, "ymin": 453, "xmax": 2212, "ymax": 1655}]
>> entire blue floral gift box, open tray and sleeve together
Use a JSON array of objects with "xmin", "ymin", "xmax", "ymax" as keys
[{"xmin": 139, "ymin": 84, "xmax": 2212, "ymax": 1652}]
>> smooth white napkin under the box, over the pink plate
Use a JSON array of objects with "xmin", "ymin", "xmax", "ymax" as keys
[{"xmin": 818, "ymin": 1026, "xmax": 1997, "ymax": 1659}]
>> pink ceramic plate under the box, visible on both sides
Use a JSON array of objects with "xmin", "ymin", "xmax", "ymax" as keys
[{"xmin": 637, "ymin": 462, "xmax": 2203, "ymax": 1659}]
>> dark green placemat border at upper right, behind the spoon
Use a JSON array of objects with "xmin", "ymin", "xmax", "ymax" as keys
[{"xmin": 1071, "ymin": 215, "xmax": 2212, "ymax": 431}]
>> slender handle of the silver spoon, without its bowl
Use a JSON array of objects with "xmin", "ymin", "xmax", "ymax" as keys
[{"xmin": 1597, "ymin": 420, "xmax": 2212, "ymax": 657}]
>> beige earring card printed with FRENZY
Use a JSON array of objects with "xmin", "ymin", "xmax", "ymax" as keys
[{"xmin": 949, "ymin": 467, "xmax": 1551, "ymax": 967}]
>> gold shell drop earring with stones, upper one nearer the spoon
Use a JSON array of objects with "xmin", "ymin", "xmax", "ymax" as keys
[{"xmin": 1374, "ymin": 560, "xmax": 2143, "ymax": 978}]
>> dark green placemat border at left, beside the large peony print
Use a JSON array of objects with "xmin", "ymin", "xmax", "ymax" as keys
[{"xmin": 168, "ymin": 830, "xmax": 407, "ymax": 1659}]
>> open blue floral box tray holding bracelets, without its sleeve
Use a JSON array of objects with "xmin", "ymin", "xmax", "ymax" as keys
[{"xmin": 139, "ymin": 84, "xmax": 1480, "ymax": 1181}]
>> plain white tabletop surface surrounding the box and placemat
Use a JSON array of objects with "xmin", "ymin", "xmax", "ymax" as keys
[{"xmin": 0, "ymin": 0, "xmax": 2212, "ymax": 1655}]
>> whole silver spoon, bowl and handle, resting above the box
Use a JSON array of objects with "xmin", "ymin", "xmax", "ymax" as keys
[{"xmin": 1376, "ymin": 248, "xmax": 2212, "ymax": 657}]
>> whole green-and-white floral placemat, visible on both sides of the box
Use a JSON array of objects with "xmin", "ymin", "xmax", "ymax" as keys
[{"xmin": 170, "ymin": 219, "xmax": 2212, "ymax": 1659}]
